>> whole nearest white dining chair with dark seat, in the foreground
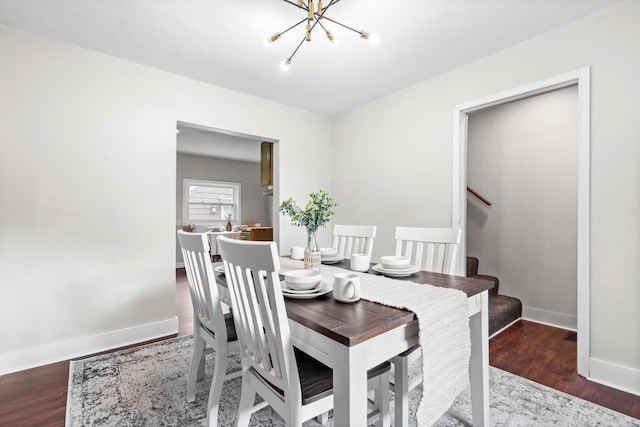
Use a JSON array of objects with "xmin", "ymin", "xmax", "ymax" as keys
[{"xmin": 218, "ymin": 236, "xmax": 390, "ymax": 426}]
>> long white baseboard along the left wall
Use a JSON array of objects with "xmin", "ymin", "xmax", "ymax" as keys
[{"xmin": 0, "ymin": 316, "xmax": 178, "ymax": 375}]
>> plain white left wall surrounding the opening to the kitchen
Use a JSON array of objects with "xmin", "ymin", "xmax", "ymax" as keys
[{"xmin": 0, "ymin": 27, "xmax": 331, "ymax": 373}]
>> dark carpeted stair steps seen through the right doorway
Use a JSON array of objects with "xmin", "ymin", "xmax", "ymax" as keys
[{"xmin": 467, "ymin": 257, "xmax": 522, "ymax": 336}]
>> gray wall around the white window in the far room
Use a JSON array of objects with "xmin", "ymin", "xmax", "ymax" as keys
[{"xmin": 176, "ymin": 153, "xmax": 273, "ymax": 262}]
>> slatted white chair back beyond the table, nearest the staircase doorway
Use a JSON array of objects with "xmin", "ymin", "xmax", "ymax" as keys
[{"xmin": 395, "ymin": 227, "xmax": 462, "ymax": 274}]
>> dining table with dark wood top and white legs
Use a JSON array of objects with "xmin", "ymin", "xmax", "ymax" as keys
[{"xmin": 216, "ymin": 257, "xmax": 494, "ymax": 426}]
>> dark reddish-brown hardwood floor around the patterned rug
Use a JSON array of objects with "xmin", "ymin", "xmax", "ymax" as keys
[{"xmin": 0, "ymin": 269, "xmax": 640, "ymax": 427}]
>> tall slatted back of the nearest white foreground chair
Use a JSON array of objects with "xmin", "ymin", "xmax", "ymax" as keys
[{"xmin": 218, "ymin": 236, "xmax": 302, "ymax": 404}]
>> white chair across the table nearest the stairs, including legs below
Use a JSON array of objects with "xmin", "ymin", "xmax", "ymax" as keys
[{"xmin": 392, "ymin": 227, "xmax": 462, "ymax": 424}]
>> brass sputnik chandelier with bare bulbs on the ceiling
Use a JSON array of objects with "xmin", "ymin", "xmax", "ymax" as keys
[{"xmin": 265, "ymin": 0, "xmax": 380, "ymax": 71}]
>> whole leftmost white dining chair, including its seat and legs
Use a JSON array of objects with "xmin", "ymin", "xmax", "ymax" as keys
[{"xmin": 178, "ymin": 230, "xmax": 242, "ymax": 427}]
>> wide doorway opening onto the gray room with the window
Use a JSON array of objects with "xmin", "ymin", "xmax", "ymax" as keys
[{"xmin": 175, "ymin": 121, "xmax": 279, "ymax": 267}]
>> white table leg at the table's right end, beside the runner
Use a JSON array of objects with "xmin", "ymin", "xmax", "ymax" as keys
[{"xmin": 469, "ymin": 291, "xmax": 489, "ymax": 427}]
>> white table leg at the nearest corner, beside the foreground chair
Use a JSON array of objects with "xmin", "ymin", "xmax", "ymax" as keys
[{"xmin": 333, "ymin": 346, "xmax": 368, "ymax": 426}]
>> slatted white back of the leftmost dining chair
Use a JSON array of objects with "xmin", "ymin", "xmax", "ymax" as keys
[{"xmin": 178, "ymin": 230, "xmax": 227, "ymax": 342}]
